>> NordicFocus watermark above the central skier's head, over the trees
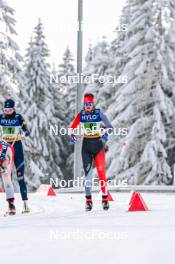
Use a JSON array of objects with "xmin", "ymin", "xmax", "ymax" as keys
[{"xmin": 50, "ymin": 73, "xmax": 128, "ymax": 84}]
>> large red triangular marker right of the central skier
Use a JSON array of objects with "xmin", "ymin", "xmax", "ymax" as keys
[{"xmin": 128, "ymin": 192, "xmax": 149, "ymax": 212}]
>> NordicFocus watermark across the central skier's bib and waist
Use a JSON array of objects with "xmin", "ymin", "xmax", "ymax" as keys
[{"xmin": 50, "ymin": 125, "xmax": 128, "ymax": 137}]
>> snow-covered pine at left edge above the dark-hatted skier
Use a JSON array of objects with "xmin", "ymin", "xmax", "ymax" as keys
[{"xmin": 0, "ymin": 0, "xmax": 23, "ymax": 103}]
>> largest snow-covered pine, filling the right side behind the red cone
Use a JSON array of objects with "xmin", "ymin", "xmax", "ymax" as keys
[{"xmin": 108, "ymin": 0, "xmax": 175, "ymax": 184}]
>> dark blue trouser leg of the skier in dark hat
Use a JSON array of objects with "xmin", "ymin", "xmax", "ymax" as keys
[{"xmin": 14, "ymin": 141, "xmax": 28, "ymax": 200}]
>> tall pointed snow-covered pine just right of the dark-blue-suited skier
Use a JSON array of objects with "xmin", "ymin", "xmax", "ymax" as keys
[{"xmin": 23, "ymin": 20, "xmax": 62, "ymax": 188}]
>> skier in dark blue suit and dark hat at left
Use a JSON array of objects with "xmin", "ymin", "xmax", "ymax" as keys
[{"xmin": 0, "ymin": 99, "xmax": 30, "ymax": 213}]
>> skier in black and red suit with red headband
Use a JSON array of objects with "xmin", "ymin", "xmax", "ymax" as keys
[{"xmin": 69, "ymin": 94, "xmax": 112, "ymax": 211}]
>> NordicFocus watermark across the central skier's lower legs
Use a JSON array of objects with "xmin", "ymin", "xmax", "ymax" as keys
[{"xmin": 50, "ymin": 176, "xmax": 128, "ymax": 188}]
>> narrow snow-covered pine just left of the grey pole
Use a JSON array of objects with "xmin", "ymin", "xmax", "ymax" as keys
[{"xmin": 57, "ymin": 48, "xmax": 77, "ymax": 180}]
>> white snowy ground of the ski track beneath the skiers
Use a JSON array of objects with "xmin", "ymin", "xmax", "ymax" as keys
[{"xmin": 0, "ymin": 193, "xmax": 175, "ymax": 264}]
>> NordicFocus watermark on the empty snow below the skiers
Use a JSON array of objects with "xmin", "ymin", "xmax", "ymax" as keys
[{"xmin": 49, "ymin": 228, "xmax": 128, "ymax": 241}]
